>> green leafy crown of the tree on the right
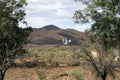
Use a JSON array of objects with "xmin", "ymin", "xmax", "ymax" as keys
[{"xmin": 73, "ymin": 0, "xmax": 120, "ymax": 49}]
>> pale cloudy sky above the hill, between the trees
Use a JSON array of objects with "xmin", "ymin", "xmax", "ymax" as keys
[{"xmin": 25, "ymin": 0, "xmax": 90, "ymax": 31}]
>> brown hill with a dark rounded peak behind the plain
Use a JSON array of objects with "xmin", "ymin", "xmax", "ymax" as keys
[{"xmin": 30, "ymin": 25, "xmax": 90, "ymax": 47}]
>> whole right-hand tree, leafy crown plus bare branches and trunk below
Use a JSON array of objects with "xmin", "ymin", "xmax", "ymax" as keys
[{"xmin": 73, "ymin": 0, "xmax": 120, "ymax": 80}]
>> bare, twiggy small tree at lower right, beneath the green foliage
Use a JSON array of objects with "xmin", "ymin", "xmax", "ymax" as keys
[{"xmin": 80, "ymin": 47, "xmax": 120, "ymax": 80}]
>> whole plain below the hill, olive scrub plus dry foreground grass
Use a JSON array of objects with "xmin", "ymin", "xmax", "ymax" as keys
[{"xmin": 5, "ymin": 46, "xmax": 120, "ymax": 80}]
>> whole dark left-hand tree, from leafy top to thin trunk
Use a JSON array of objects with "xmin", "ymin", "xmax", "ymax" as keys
[{"xmin": 0, "ymin": 0, "xmax": 32, "ymax": 80}]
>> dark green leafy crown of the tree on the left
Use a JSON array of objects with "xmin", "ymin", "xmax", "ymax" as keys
[{"xmin": 0, "ymin": 0, "xmax": 30, "ymax": 54}]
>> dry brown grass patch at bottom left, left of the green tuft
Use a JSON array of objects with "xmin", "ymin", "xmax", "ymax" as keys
[{"xmin": 5, "ymin": 68, "xmax": 39, "ymax": 80}]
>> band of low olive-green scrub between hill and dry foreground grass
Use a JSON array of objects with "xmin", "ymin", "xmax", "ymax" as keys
[{"xmin": 27, "ymin": 46, "xmax": 81, "ymax": 67}]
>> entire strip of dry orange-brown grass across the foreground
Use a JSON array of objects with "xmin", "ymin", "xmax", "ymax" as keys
[{"xmin": 5, "ymin": 66, "xmax": 120, "ymax": 80}]
